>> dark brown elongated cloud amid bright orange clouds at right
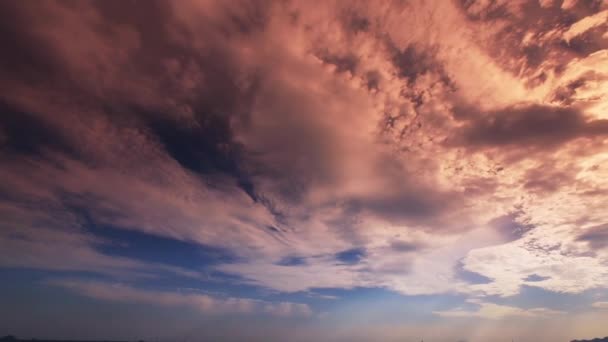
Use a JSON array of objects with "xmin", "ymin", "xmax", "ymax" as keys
[{"xmin": 448, "ymin": 105, "xmax": 608, "ymax": 150}]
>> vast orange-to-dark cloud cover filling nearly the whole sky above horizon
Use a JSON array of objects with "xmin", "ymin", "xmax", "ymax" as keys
[{"xmin": 0, "ymin": 1, "xmax": 608, "ymax": 311}]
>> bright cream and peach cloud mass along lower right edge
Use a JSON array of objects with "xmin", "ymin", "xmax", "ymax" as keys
[{"xmin": 456, "ymin": 144, "xmax": 608, "ymax": 296}]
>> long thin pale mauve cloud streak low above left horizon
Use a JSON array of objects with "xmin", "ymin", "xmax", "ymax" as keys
[{"xmin": 47, "ymin": 279, "xmax": 312, "ymax": 317}]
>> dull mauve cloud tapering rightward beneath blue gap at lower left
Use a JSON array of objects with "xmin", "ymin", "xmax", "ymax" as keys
[{"xmin": 0, "ymin": 203, "xmax": 202, "ymax": 278}]
